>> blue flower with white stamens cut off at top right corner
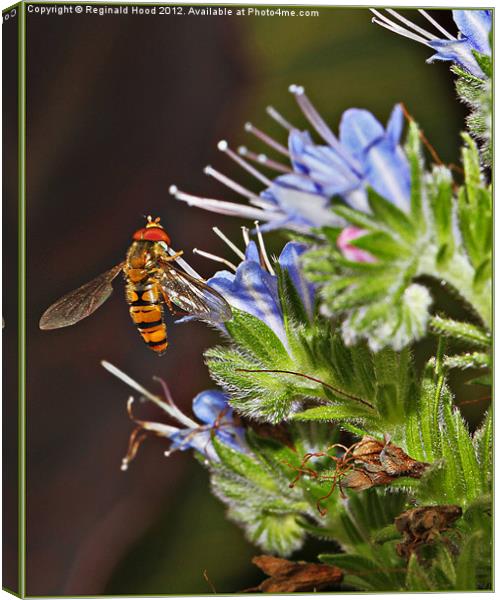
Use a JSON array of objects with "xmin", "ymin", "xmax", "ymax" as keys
[{"xmin": 371, "ymin": 9, "xmax": 492, "ymax": 79}]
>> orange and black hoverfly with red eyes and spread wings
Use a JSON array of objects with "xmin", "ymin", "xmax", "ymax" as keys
[{"xmin": 40, "ymin": 217, "xmax": 232, "ymax": 356}]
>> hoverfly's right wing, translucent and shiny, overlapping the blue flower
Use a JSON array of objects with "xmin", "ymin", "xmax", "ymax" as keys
[{"xmin": 160, "ymin": 261, "xmax": 233, "ymax": 323}]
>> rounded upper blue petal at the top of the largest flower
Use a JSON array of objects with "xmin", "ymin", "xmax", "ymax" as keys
[{"xmin": 339, "ymin": 108, "xmax": 385, "ymax": 160}]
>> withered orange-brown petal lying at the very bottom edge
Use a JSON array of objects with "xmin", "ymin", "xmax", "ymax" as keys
[{"xmin": 252, "ymin": 555, "xmax": 342, "ymax": 594}]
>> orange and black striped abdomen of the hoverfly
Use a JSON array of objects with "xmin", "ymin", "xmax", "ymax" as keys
[{"xmin": 127, "ymin": 282, "xmax": 168, "ymax": 354}]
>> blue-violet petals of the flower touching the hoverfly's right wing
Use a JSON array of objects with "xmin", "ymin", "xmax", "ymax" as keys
[{"xmin": 208, "ymin": 242, "xmax": 315, "ymax": 348}]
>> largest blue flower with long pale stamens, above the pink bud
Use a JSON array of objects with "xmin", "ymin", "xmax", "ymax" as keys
[{"xmin": 170, "ymin": 90, "xmax": 410, "ymax": 233}]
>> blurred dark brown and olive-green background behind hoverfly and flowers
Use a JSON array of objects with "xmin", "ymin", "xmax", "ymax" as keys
[{"xmin": 5, "ymin": 7, "xmax": 463, "ymax": 595}]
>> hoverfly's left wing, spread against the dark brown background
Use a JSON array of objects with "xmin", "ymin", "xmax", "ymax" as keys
[{"xmin": 40, "ymin": 263, "xmax": 124, "ymax": 329}]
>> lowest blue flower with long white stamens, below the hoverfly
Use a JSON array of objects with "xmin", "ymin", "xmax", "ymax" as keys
[{"xmin": 102, "ymin": 361, "xmax": 248, "ymax": 471}]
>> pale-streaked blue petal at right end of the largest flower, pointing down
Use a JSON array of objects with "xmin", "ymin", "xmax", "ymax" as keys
[{"xmin": 364, "ymin": 139, "xmax": 410, "ymax": 212}]
